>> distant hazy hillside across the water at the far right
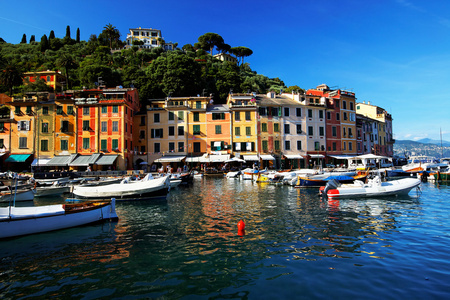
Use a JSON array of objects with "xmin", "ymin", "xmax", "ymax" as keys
[{"xmin": 394, "ymin": 140, "xmax": 450, "ymax": 158}]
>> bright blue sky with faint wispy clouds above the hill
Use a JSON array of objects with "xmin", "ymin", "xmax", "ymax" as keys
[{"xmin": 0, "ymin": 0, "xmax": 450, "ymax": 140}]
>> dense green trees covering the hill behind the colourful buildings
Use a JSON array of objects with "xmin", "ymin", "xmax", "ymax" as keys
[{"xmin": 0, "ymin": 24, "xmax": 304, "ymax": 103}]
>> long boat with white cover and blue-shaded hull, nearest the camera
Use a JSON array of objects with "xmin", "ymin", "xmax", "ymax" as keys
[{"xmin": 0, "ymin": 199, "xmax": 118, "ymax": 239}]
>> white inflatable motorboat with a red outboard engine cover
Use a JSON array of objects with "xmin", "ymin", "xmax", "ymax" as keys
[{"xmin": 321, "ymin": 176, "xmax": 420, "ymax": 199}]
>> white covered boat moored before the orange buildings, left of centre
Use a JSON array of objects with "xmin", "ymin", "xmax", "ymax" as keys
[{"xmin": 73, "ymin": 173, "xmax": 170, "ymax": 201}]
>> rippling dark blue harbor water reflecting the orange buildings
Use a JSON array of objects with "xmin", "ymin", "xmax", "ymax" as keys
[{"xmin": 0, "ymin": 178, "xmax": 450, "ymax": 299}]
